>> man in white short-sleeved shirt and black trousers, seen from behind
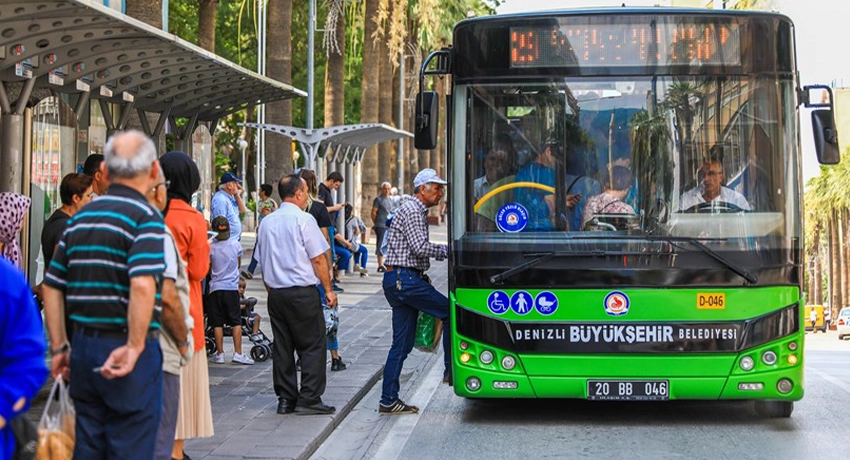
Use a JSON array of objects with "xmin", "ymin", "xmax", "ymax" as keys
[{"xmin": 257, "ymin": 174, "xmax": 337, "ymax": 414}]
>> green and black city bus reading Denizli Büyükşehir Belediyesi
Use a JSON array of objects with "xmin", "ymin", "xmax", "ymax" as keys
[{"xmin": 415, "ymin": 8, "xmax": 839, "ymax": 417}]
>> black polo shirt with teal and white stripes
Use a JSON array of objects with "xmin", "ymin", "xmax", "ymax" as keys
[{"xmin": 44, "ymin": 184, "xmax": 165, "ymax": 329}]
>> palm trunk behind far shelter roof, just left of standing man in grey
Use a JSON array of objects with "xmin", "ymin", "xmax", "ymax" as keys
[{"xmin": 360, "ymin": 0, "xmax": 380, "ymax": 226}]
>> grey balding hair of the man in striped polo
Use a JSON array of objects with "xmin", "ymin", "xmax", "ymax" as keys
[{"xmin": 103, "ymin": 130, "xmax": 157, "ymax": 179}]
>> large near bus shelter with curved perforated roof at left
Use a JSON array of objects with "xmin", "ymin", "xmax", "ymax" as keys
[{"xmin": 0, "ymin": 0, "xmax": 306, "ymax": 279}]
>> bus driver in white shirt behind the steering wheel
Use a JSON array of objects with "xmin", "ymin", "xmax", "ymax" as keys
[{"xmin": 677, "ymin": 155, "xmax": 752, "ymax": 212}]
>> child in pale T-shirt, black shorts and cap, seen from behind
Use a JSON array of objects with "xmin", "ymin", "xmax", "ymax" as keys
[{"xmin": 207, "ymin": 216, "xmax": 254, "ymax": 365}]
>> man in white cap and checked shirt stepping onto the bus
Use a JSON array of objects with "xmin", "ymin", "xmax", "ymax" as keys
[{"xmin": 378, "ymin": 168, "xmax": 451, "ymax": 415}]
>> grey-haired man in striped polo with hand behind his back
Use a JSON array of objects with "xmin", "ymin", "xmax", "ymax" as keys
[{"xmin": 44, "ymin": 131, "xmax": 165, "ymax": 459}]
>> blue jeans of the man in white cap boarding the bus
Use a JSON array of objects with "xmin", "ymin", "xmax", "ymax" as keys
[{"xmin": 381, "ymin": 267, "xmax": 451, "ymax": 405}]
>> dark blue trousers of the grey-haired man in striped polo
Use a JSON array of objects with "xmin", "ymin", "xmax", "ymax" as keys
[{"xmin": 71, "ymin": 332, "xmax": 162, "ymax": 459}]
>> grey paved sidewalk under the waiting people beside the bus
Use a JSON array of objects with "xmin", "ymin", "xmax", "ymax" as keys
[{"xmin": 185, "ymin": 226, "xmax": 448, "ymax": 460}]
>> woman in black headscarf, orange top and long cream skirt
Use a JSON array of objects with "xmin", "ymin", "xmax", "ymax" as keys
[{"xmin": 159, "ymin": 152, "xmax": 213, "ymax": 459}]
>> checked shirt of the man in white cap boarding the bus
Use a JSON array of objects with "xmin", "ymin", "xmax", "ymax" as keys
[{"xmin": 384, "ymin": 198, "xmax": 449, "ymax": 271}]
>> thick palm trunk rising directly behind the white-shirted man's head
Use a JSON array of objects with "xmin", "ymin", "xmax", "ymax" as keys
[{"xmin": 266, "ymin": 0, "xmax": 293, "ymax": 199}]
